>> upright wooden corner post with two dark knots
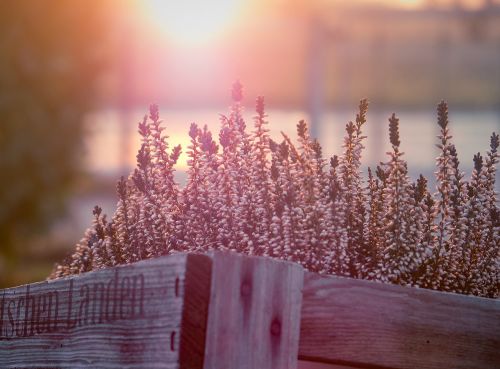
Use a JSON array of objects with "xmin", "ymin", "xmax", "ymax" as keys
[{"xmin": 204, "ymin": 253, "xmax": 303, "ymax": 369}]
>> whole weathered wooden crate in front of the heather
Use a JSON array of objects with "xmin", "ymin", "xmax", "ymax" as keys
[{"xmin": 0, "ymin": 253, "xmax": 500, "ymax": 369}]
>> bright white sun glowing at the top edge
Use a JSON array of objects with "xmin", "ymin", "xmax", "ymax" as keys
[{"xmin": 143, "ymin": 0, "xmax": 245, "ymax": 46}]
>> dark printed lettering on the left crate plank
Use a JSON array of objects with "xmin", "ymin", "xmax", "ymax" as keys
[{"xmin": 0, "ymin": 269, "xmax": 150, "ymax": 340}]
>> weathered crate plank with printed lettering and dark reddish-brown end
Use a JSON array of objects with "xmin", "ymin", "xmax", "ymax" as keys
[{"xmin": 0, "ymin": 254, "xmax": 211, "ymax": 369}]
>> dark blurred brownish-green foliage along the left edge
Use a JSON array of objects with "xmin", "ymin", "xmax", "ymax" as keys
[{"xmin": 0, "ymin": 0, "xmax": 114, "ymax": 286}]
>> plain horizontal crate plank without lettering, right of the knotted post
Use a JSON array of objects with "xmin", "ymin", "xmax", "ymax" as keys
[{"xmin": 299, "ymin": 273, "xmax": 500, "ymax": 369}]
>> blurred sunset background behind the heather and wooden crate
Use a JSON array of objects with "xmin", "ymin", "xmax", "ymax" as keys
[{"xmin": 0, "ymin": 0, "xmax": 500, "ymax": 287}]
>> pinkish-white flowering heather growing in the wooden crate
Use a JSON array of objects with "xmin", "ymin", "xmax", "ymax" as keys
[{"xmin": 51, "ymin": 83, "xmax": 500, "ymax": 298}]
